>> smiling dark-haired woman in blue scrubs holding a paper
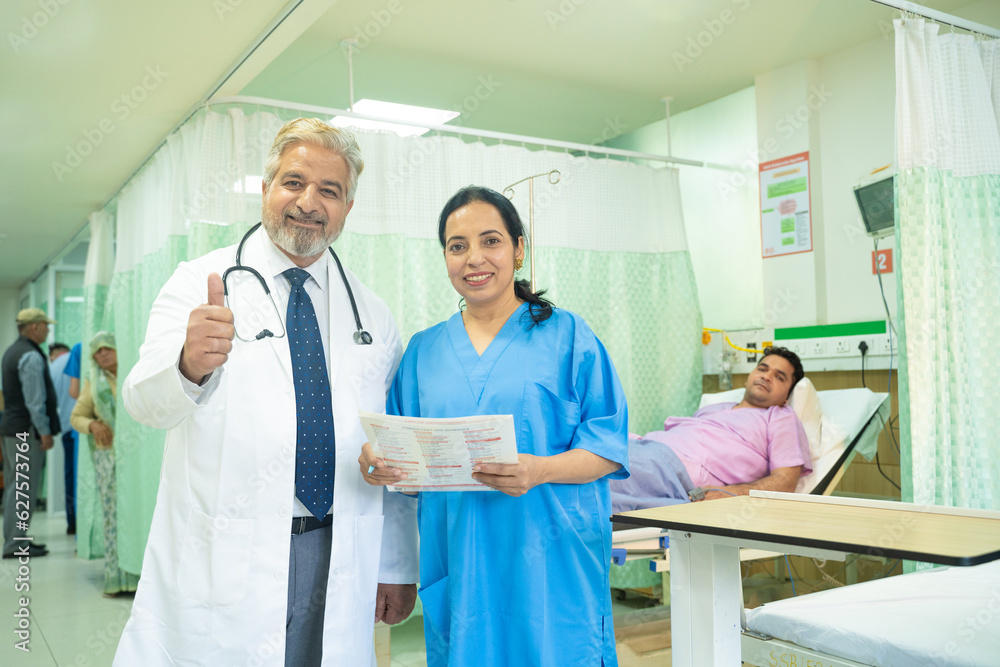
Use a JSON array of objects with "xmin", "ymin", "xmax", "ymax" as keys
[{"xmin": 359, "ymin": 187, "xmax": 628, "ymax": 667}]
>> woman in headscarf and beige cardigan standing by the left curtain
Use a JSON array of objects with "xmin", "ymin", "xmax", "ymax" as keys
[{"xmin": 70, "ymin": 331, "xmax": 139, "ymax": 597}]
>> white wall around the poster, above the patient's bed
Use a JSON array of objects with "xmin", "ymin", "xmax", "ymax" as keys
[{"xmin": 609, "ymin": 34, "xmax": 896, "ymax": 331}]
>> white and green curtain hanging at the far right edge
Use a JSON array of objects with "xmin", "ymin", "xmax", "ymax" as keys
[{"xmin": 895, "ymin": 19, "xmax": 1000, "ymax": 509}]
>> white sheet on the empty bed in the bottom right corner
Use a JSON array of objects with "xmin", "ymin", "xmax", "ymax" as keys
[{"xmin": 746, "ymin": 561, "xmax": 1000, "ymax": 667}]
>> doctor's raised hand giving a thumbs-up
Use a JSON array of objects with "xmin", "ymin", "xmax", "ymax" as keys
[{"xmin": 180, "ymin": 273, "xmax": 236, "ymax": 384}]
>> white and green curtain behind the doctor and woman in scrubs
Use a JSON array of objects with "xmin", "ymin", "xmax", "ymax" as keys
[{"xmin": 111, "ymin": 106, "xmax": 702, "ymax": 571}]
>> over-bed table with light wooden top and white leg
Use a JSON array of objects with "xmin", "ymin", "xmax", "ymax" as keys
[{"xmin": 612, "ymin": 491, "xmax": 1000, "ymax": 667}]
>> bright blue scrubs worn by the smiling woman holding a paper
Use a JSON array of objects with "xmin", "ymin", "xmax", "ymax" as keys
[{"xmin": 388, "ymin": 304, "xmax": 628, "ymax": 667}]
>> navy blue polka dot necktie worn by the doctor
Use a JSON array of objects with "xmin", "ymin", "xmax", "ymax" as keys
[{"xmin": 282, "ymin": 269, "xmax": 336, "ymax": 519}]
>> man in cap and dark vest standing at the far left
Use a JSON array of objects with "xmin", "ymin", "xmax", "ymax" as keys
[{"xmin": 0, "ymin": 308, "xmax": 59, "ymax": 558}]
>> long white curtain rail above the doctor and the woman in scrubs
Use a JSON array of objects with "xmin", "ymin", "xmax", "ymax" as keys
[{"xmin": 205, "ymin": 95, "xmax": 735, "ymax": 170}]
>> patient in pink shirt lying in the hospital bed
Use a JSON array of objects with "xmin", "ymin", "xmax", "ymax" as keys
[{"xmin": 611, "ymin": 347, "xmax": 812, "ymax": 512}]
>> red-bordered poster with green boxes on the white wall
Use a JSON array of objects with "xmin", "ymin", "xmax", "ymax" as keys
[{"xmin": 760, "ymin": 152, "xmax": 812, "ymax": 258}]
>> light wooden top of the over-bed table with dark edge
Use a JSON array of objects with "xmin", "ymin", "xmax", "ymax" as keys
[{"xmin": 612, "ymin": 494, "xmax": 1000, "ymax": 566}]
